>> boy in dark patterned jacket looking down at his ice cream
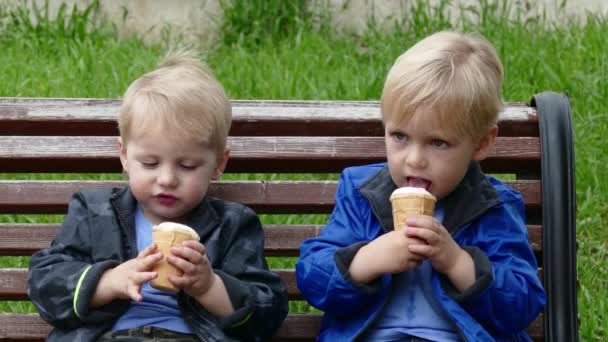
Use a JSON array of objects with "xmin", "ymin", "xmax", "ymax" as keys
[{"xmin": 28, "ymin": 53, "xmax": 287, "ymax": 342}]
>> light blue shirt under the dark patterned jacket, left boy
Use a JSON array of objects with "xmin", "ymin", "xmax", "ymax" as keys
[{"xmin": 112, "ymin": 207, "xmax": 192, "ymax": 334}]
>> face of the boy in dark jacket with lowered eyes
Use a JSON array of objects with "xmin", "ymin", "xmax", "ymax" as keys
[{"xmin": 120, "ymin": 130, "xmax": 228, "ymax": 224}]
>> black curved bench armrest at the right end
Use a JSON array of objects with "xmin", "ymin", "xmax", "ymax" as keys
[{"xmin": 531, "ymin": 92, "xmax": 578, "ymax": 342}]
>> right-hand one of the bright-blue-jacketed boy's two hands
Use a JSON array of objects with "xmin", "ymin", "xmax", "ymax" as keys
[{"xmin": 405, "ymin": 215, "xmax": 468, "ymax": 274}]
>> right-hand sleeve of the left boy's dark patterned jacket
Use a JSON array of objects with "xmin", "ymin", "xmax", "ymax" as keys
[{"xmin": 208, "ymin": 207, "xmax": 288, "ymax": 341}]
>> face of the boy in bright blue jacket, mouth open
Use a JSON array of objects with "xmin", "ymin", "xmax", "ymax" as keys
[{"xmin": 385, "ymin": 111, "xmax": 496, "ymax": 199}]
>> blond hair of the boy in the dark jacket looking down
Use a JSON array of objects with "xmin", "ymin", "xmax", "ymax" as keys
[{"xmin": 118, "ymin": 51, "xmax": 232, "ymax": 153}]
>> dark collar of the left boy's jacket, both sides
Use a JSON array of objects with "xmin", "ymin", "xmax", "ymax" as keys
[{"xmin": 112, "ymin": 187, "xmax": 221, "ymax": 241}]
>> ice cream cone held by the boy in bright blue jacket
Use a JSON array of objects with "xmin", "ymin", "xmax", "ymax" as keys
[{"xmin": 390, "ymin": 187, "xmax": 436, "ymax": 230}]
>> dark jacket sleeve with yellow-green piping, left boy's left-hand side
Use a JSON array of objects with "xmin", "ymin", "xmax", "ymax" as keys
[{"xmin": 27, "ymin": 193, "xmax": 122, "ymax": 329}]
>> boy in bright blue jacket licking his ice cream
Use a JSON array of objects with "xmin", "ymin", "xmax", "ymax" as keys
[{"xmin": 296, "ymin": 32, "xmax": 545, "ymax": 342}]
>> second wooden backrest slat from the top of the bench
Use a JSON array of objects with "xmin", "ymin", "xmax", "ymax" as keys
[{"xmin": 0, "ymin": 136, "xmax": 540, "ymax": 173}]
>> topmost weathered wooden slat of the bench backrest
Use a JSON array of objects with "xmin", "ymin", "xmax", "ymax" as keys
[{"xmin": 0, "ymin": 98, "xmax": 538, "ymax": 136}]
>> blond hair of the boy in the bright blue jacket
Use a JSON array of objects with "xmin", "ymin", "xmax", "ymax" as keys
[{"xmin": 381, "ymin": 31, "xmax": 503, "ymax": 139}]
